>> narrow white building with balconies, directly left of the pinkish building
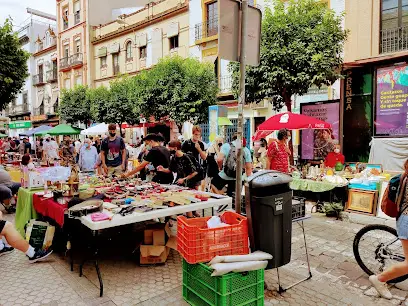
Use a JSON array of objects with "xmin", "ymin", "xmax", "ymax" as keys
[{"xmin": 31, "ymin": 26, "xmax": 59, "ymax": 127}]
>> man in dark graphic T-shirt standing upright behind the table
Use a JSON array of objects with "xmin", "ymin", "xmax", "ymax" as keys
[{"xmin": 101, "ymin": 123, "xmax": 126, "ymax": 175}]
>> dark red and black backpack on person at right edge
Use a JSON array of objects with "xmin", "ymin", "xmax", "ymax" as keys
[{"xmin": 381, "ymin": 174, "xmax": 407, "ymax": 219}]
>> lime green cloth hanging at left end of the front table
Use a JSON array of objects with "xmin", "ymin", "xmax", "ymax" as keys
[{"xmin": 15, "ymin": 188, "xmax": 41, "ymax": 237}]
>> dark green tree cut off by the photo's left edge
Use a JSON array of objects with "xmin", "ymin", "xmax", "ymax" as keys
[{"xmin": 0, "ymin": 19, "xmax": 30, "ymax": 109}]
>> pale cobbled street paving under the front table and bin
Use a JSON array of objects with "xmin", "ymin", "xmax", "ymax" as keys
[{"xmin": 0, "ymin": 210, "xmax": 408, "ymax": 306}]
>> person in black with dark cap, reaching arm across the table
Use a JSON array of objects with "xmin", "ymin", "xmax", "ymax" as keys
[{"xmin": 122, "ymin": 134, "xmax": 174, "ymax": 184}]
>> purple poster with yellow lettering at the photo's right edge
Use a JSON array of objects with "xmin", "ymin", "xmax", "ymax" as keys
[{"xmin": 374, "ymin": 65, "xmax": 408, "ymax": 136}]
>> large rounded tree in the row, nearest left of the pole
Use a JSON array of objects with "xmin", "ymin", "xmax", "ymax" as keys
[{"xmin": 143, "ymin": 56, "xmax": 218, "ymax": 126}]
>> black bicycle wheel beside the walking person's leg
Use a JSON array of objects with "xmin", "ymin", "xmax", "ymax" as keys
[{"xmin": 353, "ymin": 224, "xmax": 408, "ymax": 283}]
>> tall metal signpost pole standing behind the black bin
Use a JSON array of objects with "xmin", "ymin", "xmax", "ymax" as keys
[{"xmin": 235, "ymin": 0, "xmax": 248, "ymax": 213}]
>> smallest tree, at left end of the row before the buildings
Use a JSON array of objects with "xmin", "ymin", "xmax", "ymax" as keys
[{"xmin": 59, "ymin": 85, "xmax": 92, "ymax": 127}]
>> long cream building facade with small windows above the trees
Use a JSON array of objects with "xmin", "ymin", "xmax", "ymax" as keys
[{"xmin": 91, "ymin": 0, "xmax": 189, "ymax": 87}]
